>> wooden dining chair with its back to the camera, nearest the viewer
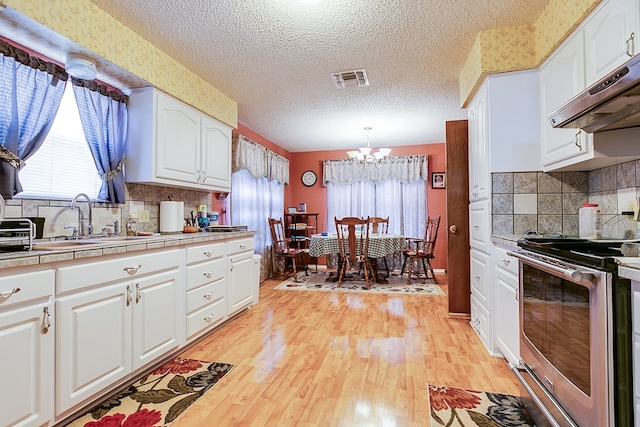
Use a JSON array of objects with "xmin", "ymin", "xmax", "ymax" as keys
[{"xmin": 334, "ymin": 217, "xmax": 375, "ymax": 289}]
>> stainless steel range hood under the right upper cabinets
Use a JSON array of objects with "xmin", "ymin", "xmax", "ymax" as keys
[{"xmin": 548, "ymin": 55, "xmax": 640, "ymax": 133}]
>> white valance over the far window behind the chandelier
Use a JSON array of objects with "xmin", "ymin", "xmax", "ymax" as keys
[{"xmin": 322, "ymin": 154, "xmax": 429, "ymax": 185}]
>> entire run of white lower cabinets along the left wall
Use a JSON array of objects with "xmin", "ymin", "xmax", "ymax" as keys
[{"xmin": 0, "ymin": 236, "xmax": 259, "ymax": 427}]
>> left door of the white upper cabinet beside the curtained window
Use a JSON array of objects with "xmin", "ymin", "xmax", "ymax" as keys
[{"xmin": 155, "ymin": 92, "xmax": 200, "ymax": 183}]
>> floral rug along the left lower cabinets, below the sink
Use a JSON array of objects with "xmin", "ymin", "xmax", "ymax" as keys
[{"xmin": 68, "ymin": 357, "xmax": 233, "ymax": 427}]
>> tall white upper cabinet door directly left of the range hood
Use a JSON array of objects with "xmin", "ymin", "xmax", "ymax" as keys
[{"xmin": 540, "ymin": 32, "xmax": 592, "ymax": 166}]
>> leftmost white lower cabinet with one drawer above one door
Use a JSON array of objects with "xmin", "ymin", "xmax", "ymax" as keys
[{"xmin": 0, "ymin": 270, "xmax": 55, "ymax": 427}]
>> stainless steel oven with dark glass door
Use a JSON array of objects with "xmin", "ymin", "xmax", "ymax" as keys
[{"xmin": 512, "ymin": 241, "xmax": 633, "ymax": 426}]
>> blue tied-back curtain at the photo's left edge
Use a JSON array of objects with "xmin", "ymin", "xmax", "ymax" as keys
[{"xmin": 0, "ymin": 40, "xmax": 67, "ymax": 199}]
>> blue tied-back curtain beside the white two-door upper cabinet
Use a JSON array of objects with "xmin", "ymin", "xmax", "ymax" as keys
[{"xmin": 72, "ymin": 78, "xmax": 128, "ymax": 203}]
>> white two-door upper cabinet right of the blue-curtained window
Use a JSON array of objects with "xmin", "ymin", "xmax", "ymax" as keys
[{"xmin": 125, "ymin": 88, "xmax": 231, "ymax": 191}]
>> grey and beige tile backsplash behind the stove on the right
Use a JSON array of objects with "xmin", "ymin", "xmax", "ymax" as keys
[{"xmin": 491, "ymin": 160, "xmax": 640, "ymax": 239}]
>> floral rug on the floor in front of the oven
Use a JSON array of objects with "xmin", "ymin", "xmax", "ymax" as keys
[{"xmin": 428, "ymin": 384, "xmax": 535, "ymax": 427}]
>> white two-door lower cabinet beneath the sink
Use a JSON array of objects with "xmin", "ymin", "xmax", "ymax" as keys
[{"xmin": 56, "ymin": 250, "xmax": 183, "ymax": 415}]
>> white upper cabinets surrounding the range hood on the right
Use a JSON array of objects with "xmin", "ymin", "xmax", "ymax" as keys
[{"xmin": 540, "ymin": 0, "xmax": 640, "ymax": 172}]
